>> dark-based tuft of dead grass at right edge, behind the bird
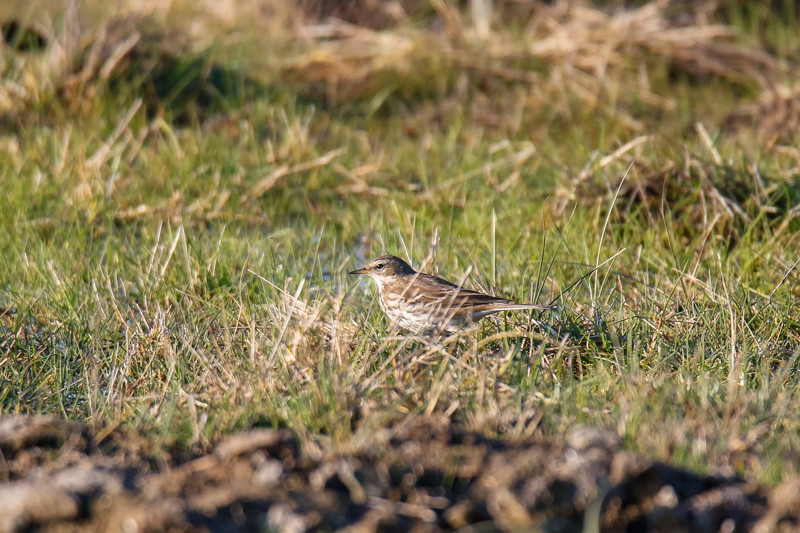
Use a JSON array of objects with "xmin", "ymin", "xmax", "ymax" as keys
[{"xmin": 552, "ymin": 130, "xmax": 800, "ymax": 241}]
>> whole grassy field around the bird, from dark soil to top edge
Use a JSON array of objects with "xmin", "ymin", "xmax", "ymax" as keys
[{"xmin": 0, "ymin": 0, "xmax": 800, "ymax": 484}]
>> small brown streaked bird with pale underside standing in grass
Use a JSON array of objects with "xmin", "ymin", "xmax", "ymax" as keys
[{"xmin": 350, "ymin": 255, "xmax": 552, "ymax": 333}]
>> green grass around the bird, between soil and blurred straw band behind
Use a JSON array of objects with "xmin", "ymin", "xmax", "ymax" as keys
[{"xmin": 0, "ymin": 0, "xmax": 800, "ymax": 483}]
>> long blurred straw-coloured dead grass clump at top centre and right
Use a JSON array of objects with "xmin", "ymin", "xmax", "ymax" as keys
[{"xmin": 278, "ymin": 1, "xmax": 784, "ymax": 114}]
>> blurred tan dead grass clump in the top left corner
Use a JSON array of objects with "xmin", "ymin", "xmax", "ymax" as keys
[{"xmin": 0, "ymin": 1, "xmax": 295, "ymax": 115}]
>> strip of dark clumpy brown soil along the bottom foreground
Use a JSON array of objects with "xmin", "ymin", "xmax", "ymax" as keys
[{"xmin": 0, "ymin": 416, "xmax": 800, "ymax": 533}]
